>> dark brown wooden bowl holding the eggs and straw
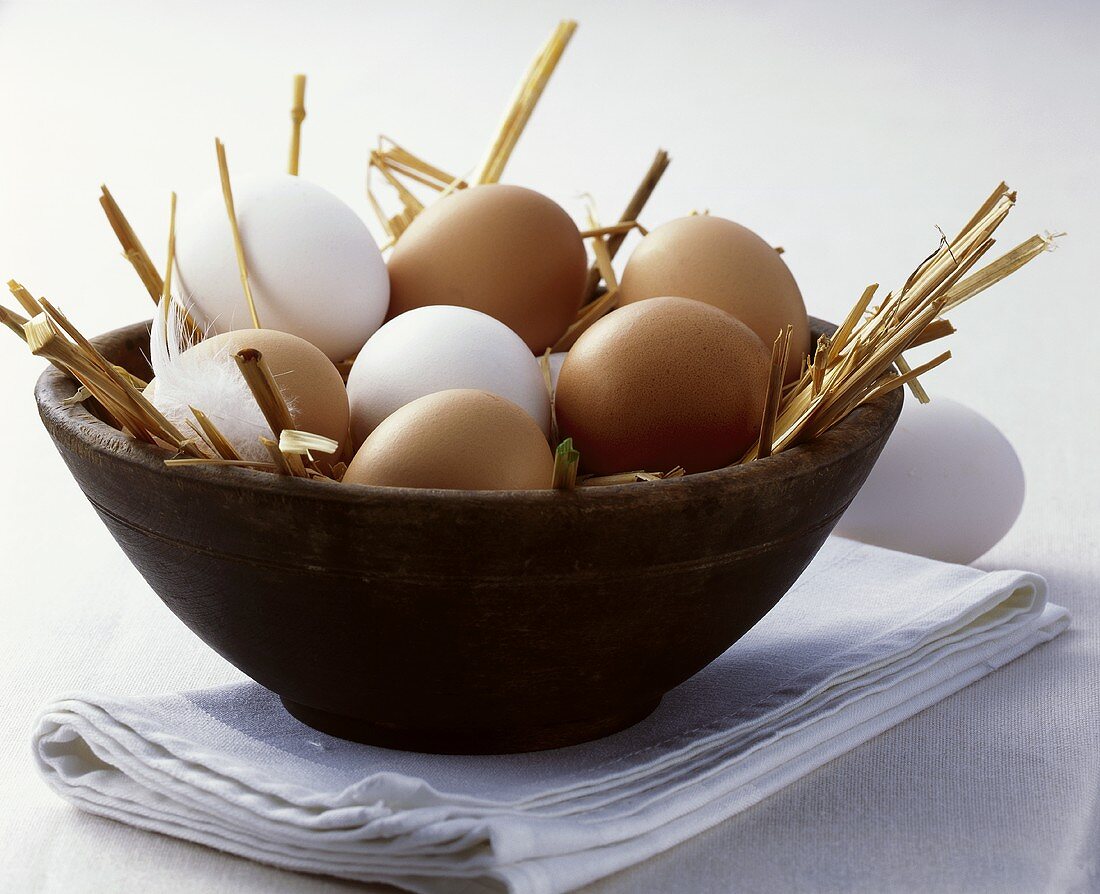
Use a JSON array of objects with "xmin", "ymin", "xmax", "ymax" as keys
[{"xmin": 35, "ymin": 321, "xmax": 902, "ymax": 753}]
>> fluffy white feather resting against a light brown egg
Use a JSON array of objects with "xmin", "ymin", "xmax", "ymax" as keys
[{"xmin": 150, "ymin": 299, "xmax": 281, "ymax": 462}]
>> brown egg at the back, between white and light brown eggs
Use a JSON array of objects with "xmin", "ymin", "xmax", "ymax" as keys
[{"xmin": 388, "ymin": 184, "xmax": 587, "ymax": 354}]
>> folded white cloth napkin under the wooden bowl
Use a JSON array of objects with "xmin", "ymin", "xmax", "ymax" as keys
[{"xmin": 34, "ymin": 538, "xmax": 1069, "ymax": 894}]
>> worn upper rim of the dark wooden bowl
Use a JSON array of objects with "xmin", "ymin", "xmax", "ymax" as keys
[{"xmin": 34, "ymin": 317, "xmax": 903, "ymax": 507}]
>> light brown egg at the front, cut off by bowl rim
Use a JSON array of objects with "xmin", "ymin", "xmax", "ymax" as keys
[{"xmin": 343, "ymin": 388, "xmax": 553, "ymax": 490}]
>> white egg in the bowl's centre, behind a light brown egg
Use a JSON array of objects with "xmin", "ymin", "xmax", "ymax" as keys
[{"xmin": 348, "ymin": 305, "xmax": 550, "ymax": 443}]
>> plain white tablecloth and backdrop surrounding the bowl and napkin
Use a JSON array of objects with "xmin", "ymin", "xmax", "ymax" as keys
[{"xmin": 0, "ymin": 0, "xmax": 1100, "ymax": 892}]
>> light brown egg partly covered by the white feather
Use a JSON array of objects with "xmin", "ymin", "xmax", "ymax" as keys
[{"xmin": 178, "ymin": 329, "xmax": 350, "ymax": 460}]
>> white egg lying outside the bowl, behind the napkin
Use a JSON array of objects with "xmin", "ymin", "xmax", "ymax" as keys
[{"xmin": 836, "ymin": 395, "xmax": 1024, "ymax": 564}]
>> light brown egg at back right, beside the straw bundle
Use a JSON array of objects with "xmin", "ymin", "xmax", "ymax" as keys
[{"xmin": 619, "ymin": 214, "xmax": 810, "ymax": 380}]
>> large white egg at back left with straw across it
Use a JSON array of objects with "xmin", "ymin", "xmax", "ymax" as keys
[{"xmin": 176, "ymin": 174, "xmax": 389, "ymax": 362}]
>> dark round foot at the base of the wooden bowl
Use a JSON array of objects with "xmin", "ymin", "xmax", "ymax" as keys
[{"xmin": 279, "ymin": 696, "xmax": 661, "ymax": 754}]
